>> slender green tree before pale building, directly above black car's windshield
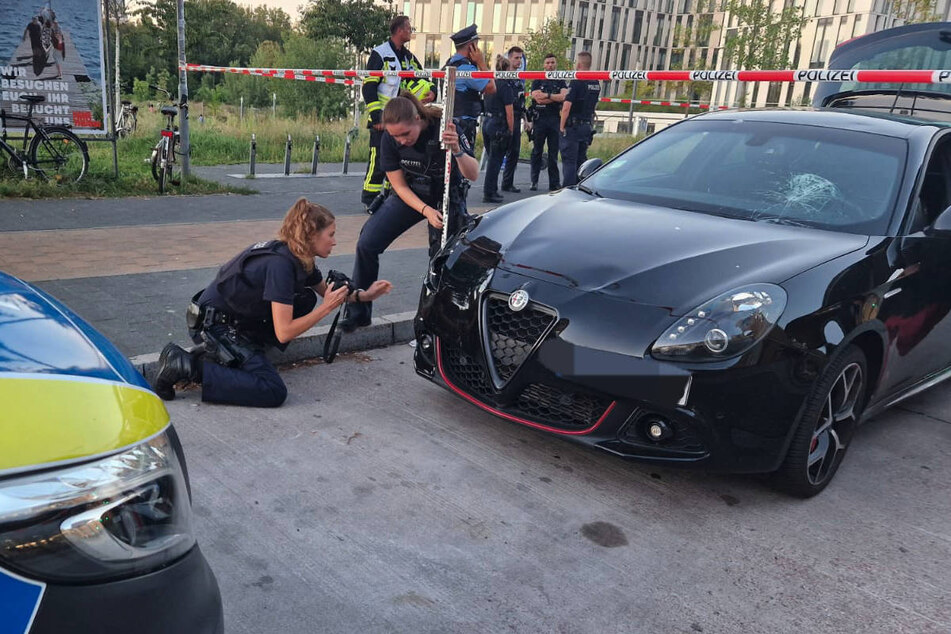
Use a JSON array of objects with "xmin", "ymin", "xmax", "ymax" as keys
[{"xmin": 723, "ymin": 0, "xmax": 808, "ymax": 105}]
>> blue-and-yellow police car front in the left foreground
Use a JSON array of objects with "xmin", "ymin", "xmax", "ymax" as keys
[{"xmin": 0, "ymin": 273, "xmax": 223, "ymax": 634}]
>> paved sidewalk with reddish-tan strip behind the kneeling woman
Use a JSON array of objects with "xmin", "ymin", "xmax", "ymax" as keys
[{"xmin": 0, "ymin": 163, "xmax": 544, "ymax": 357}]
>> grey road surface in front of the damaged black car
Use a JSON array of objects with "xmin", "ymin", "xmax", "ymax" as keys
[{"xmin": 169, "ymin": 345, "xmax": 951, "ymax": 634}]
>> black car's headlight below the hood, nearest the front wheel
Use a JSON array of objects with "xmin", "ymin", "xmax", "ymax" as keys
[{"xmin": 651, "ymin": 284, "xmax": 786, "ymax": 361}]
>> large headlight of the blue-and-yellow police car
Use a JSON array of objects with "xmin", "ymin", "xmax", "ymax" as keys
[{"xmin": 0, "ymin": 432, "xmax": 195, "ymax": 582}]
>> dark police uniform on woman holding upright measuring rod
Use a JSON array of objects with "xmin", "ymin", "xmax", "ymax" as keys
[{"xmin": 342, "ymin": 119, "xmax": 474, "ymax": 331}]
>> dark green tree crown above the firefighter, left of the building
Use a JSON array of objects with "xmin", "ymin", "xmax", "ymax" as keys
[{"xmin": 300, "ymin": 0, "xmax": 396, "ymax": 53}]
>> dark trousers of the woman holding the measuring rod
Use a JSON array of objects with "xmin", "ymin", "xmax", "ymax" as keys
[{"xmin": 347, "ymin": 192, "xmax": 469, "ymax": 320}]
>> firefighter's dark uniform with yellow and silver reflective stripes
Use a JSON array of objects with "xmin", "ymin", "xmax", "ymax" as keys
[{"xmin": 361, "ymin": 40, "xmax": 436, "ymax": 205}]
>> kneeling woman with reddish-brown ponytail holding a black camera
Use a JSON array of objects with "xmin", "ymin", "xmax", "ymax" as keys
[{"xmin": 153, "ymin": 198, "xmax": 391, "ymax": 407}]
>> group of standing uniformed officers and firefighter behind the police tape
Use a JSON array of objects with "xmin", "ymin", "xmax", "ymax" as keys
[{"xmin": 361, "ymin": 15, "xmax": 601, "ymax": 214}]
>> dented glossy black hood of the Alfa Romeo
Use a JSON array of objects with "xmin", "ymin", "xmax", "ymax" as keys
[{"xmin": 468, "ymin": 190, "xmax": 869, "ymax": 314}]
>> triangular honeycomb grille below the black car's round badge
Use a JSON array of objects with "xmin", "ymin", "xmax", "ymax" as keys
[{"xmin": 485, "ymin": 297, "xmax": 555, "ymax": 387}]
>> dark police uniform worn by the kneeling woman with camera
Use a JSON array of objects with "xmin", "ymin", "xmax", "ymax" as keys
[{"xmin": 189, "ymin": 240, "xmax": 323, "ymax": 407}]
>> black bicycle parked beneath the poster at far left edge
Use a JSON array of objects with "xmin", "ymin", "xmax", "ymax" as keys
[{"xmin": 0, "ymin": 95, "xmax": 89, "ymax": 183}]
